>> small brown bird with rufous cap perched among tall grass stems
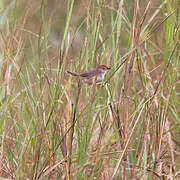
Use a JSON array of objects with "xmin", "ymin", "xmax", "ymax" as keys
[{"xmin": 67, "ymin": 65, "xmax": 111, "ymax": 84}]
